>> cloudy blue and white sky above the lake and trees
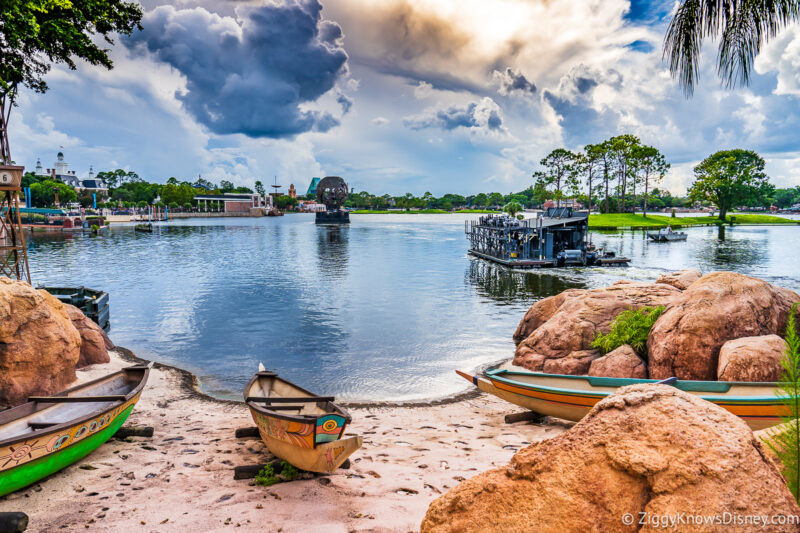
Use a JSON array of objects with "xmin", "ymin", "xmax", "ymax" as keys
[{"xmin": 10, "ymin": 0, "xmax": 800, "ymax": 195}]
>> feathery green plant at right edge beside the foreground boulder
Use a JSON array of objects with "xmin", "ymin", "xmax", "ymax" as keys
[{"xmin": 765, "ymin": 304, "xmax": 800, "ymax": 502}]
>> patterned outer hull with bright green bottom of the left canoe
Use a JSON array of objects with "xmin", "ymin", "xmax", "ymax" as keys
[{"xmin": 0, "ymin": 394, "xmax": 140, "ymax": 496}]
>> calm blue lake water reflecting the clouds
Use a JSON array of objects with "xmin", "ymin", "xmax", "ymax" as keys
[{"xmin": 25, "ymin": 215, "xmax": 800, "ymax": 400}]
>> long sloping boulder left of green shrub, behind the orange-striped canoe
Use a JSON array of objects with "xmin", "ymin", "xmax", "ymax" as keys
[{"xmin": 514, "ymin": 281, "xmax": 681, "ymax": 372}]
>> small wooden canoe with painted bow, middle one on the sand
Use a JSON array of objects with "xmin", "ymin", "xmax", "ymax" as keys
[{"xmin": 244, "ymin": 364, "xmax": 362, "ymax": 473}]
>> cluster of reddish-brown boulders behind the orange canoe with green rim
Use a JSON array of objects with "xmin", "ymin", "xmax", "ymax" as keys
[{"xmin": 514, "ymin": 270, "xmax": 800, "ymax": 381}]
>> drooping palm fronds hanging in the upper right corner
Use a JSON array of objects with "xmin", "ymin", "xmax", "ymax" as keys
[{"xmin": 664, "ymin": 0, "xmax": 800, "ymax": 97}]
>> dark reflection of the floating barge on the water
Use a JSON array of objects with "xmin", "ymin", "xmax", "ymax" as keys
[{"xmin": 465, "ymin": 258, "xmax": 587, "ymax": 304}]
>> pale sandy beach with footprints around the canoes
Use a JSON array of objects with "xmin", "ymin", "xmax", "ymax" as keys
[{"xmin": 0, "ymin": 351, "xmax": 565, "ymax": 533}]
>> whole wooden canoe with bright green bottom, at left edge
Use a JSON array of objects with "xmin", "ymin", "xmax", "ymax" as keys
[{"xmin": 0, "ymin": 363, "xmax": 152, "ymax": 496}]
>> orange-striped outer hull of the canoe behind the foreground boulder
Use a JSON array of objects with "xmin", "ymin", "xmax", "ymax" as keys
[{"xmin": 458, "ymin": 372, "xmax": 784, "ymax": 431}]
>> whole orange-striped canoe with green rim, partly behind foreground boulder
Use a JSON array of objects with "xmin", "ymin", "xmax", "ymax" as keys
[{"xmin": 456, "ymin": 369, "xmax": 784, "ymax": 431}]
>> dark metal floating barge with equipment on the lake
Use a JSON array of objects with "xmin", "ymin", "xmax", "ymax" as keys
[{"xmin": 464, "ymin": 207, "xmax": 630, "ymax": 268}]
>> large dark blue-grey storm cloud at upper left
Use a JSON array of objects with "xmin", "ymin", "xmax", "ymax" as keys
[{"xmin": 123, "ymin": 0, "xmax": 349, "ymax": 138}]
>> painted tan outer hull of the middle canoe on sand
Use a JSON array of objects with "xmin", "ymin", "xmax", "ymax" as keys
[{"xmin": 250, "ymin": 408, "xmax": 363, "ymax": 474}]
